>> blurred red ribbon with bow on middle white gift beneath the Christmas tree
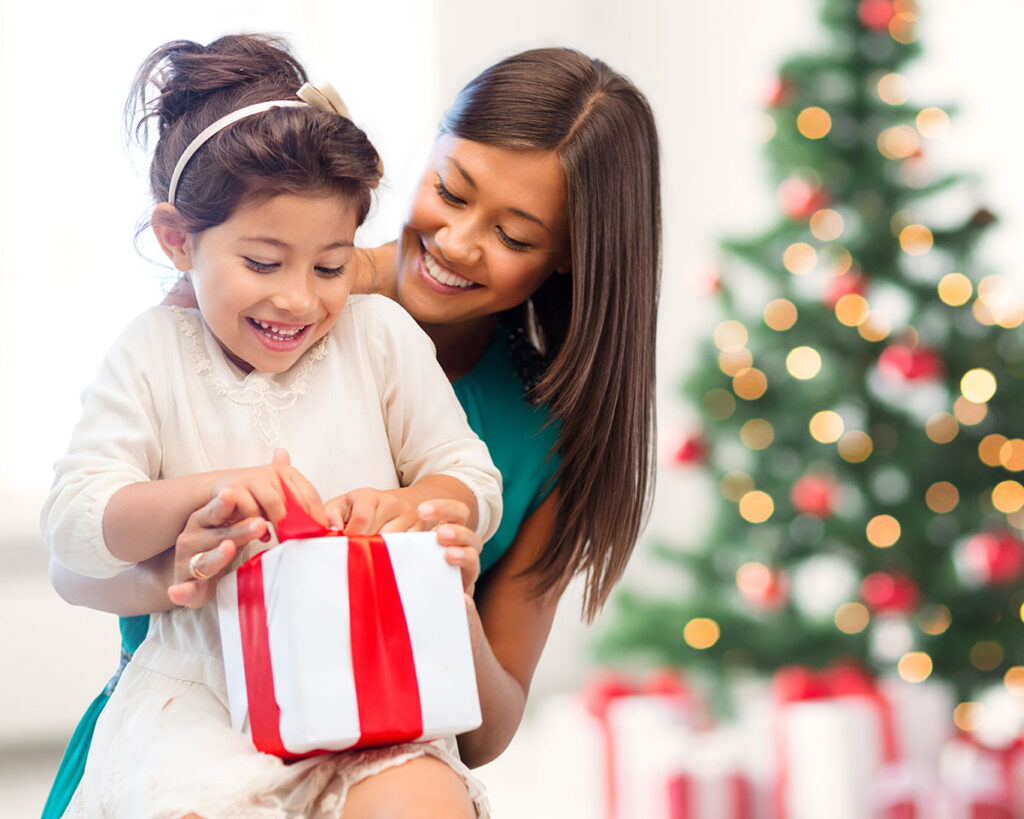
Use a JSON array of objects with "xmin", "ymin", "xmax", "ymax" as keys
[{"xmin": 772, "ymin": 663, "xmax": 899, "ymax": 819}]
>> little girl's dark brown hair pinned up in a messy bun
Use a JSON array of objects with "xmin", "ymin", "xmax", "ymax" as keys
[{"xmin": 125, "ymin": 35, "xmax": 381, "ymax": 232}]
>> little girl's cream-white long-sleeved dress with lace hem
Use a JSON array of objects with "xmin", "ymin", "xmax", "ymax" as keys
[{"xmin": 42, "ymin": 296, "xmax": 501, "ymax": 819}]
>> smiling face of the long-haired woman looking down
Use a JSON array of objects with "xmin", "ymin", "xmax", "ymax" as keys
[{"xmin": 398, "ymin": 134, "xmax": 569, "ymax": 333}]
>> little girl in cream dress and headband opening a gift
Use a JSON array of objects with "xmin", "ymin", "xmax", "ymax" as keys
[{"xmin": 43, "ymin": 37, "xmax": 501, "ymax": 819}]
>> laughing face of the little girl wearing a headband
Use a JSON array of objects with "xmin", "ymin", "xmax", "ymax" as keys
[{"xmin": 183, "ymin": 193, "xmax": 356, "ymax": 373}]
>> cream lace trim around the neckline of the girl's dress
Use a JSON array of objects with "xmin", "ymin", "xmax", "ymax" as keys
[{"xmin": 171, "ymin": 307, "xmax": 330, "ymax": 446}]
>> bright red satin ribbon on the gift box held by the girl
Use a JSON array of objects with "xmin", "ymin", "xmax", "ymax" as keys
[{"xmin": 238, "ymin": 486, "xmax": 423, "ymax": 759}]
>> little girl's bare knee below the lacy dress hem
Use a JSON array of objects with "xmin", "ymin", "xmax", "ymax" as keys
[{"xmin": 344, "ymin": 756, "xmax": 476, "ymax": 819}]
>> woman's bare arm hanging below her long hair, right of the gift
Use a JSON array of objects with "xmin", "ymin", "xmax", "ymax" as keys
[{"xmin": 459, "ymin": 487, "xmax": 561, "ymax": 768}]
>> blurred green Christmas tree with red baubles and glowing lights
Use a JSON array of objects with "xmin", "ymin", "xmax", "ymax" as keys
[{"xmin": 599, "ymin": 0, "xmax": 1024, "ymax": 716}]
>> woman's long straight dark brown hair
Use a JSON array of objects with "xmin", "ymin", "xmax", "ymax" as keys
[{"xmin": 441, "ymin": 48, "xmax": 662, "ymax": 617}]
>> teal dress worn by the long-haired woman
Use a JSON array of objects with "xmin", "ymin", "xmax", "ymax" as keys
[{"xmin": 42, "ymin": 332, "xmax": 560, "ymax": 819}]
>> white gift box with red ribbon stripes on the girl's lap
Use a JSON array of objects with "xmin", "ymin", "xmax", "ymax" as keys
[{"xmin": 217, "ymin": 532, "xmax": 480, "ymax": 759}]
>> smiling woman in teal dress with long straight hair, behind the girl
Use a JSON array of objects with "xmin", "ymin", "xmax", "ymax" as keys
[{"xmin": 44, "ymin": 48, "xmax": 660, "ymax": 817}]
